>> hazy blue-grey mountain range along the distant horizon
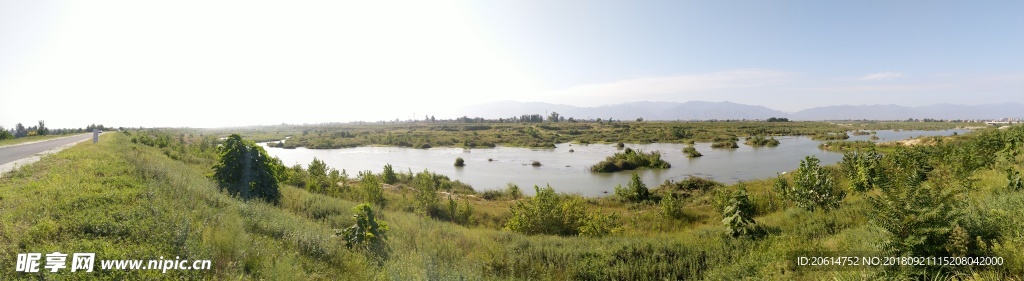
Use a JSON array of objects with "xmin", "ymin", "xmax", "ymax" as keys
[{"xmin": 461, "ymin": 101, "xmax": 1024, "ymax": 120}]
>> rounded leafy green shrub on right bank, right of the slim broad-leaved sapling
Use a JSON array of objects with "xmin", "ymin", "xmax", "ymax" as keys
[{"xmin": 775, "ymin": 156, "xmax": 846, "ymax": 211}]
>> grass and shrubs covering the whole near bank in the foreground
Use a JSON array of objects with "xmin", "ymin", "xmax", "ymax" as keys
[{"xmin": 0, "ymin": 122, "xmax": 1024, "ymax": 280}]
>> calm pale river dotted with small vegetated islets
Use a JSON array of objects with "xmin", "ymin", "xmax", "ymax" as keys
[{"xmin": 261, "ymin": 129, "xmax": 969, "ymax": 197}]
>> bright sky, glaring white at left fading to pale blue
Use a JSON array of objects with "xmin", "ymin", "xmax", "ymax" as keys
[{"xmin": 0, "ymin": 0, "xmax": 1024, "ymax": 129}]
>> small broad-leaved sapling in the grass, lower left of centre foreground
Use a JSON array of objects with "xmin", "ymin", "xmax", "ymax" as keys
[{"xmin": 341, "ymin": 203, "xmax": 388, "ymax": 255}]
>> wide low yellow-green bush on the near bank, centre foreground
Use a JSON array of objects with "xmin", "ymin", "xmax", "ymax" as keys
[{"xmin": 505, "ymin": 186, "xmax": 614, "ymax": 236}]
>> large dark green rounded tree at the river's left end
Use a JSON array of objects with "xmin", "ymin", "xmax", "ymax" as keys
[{"xmin": 213, "ymin": 134, "xmax": 284, "ymax": 204}]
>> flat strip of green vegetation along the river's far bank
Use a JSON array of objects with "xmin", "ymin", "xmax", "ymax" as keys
[{"xmin": 222, "ymin": 119, "xmax": 984, "ymax": 149}]
